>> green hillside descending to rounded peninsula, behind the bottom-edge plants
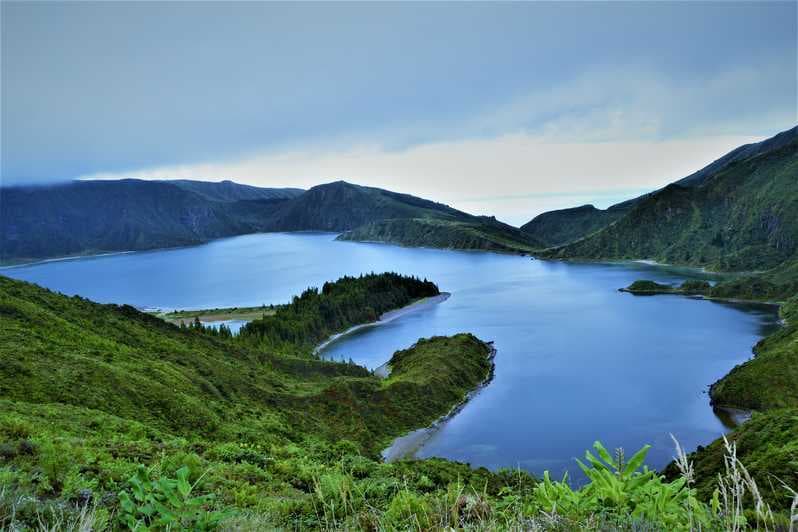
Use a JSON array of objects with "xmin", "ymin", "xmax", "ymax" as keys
[{"xmin": 0, "ymin": 277, "xmax": 520, "ymax": 527}]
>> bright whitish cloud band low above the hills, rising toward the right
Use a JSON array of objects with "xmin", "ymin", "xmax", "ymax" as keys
[{"xmin": 78, "ymin": 57, "xmax": 796, "ymax": 224}]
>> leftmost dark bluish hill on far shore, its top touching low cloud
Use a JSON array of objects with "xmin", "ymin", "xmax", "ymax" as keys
[{"xmin": 0, "ymin": 179, "xmax": 301, "ymax": 262}]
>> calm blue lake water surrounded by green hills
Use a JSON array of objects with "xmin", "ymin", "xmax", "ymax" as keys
[{"xmin": 0, "ymin": 233, "xmax": 777, "ymax": 475}]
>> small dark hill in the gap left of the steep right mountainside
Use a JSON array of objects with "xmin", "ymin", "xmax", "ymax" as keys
[{"xmin": 521, "ymin": 202, "xmax": 631, "ymax": 247}]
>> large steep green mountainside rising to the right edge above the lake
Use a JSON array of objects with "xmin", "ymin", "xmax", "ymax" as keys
[{"xmin": 533, "ymin": 128, "xmax": 798, "ymax": 271}]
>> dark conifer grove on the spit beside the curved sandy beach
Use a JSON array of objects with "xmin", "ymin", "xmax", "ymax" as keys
[{"xmin": 240, "ymin": 273, "xmax": 440, "ymax": 348}]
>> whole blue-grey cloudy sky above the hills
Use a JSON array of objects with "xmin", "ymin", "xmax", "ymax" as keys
[{"xmin": 0, "ymin": 1, "xmax": 798, "ymax": 224}]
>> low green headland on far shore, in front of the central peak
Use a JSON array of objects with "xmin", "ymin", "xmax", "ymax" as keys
[{"xmin": 338, "ymin": 218, "xmax": 543, "ymax": 252}]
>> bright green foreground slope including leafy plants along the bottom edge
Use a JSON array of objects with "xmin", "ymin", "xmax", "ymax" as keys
[{"xmin": 0, "ymin": 274, "xmax": 792, "ymax": 530}]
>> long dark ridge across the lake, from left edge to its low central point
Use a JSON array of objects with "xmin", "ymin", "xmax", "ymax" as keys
[{"xmin": 0, "ymin": 179, "xmax": 539, "ymax": 263}]
